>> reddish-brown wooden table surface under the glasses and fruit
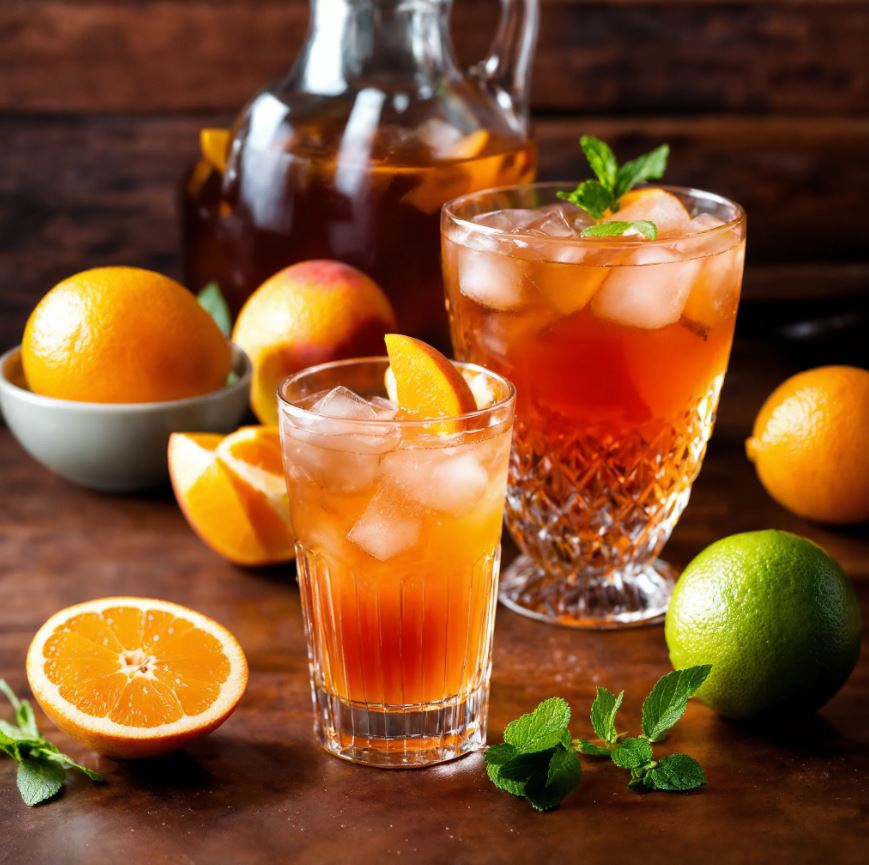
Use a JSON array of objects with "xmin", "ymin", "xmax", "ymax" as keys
[{"xmin": 0, "ymin": 344, "xmax": 869, "ymax": 865}]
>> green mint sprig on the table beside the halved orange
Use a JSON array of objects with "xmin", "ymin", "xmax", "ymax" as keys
[{"xmin": 0, "ymin": 679, "xmax": 104, "ymax": 805}]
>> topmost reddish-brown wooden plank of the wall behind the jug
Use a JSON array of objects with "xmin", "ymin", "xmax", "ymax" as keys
[{"xmin": 0, "ymin": 0, "xmax": 869, "ymax": 115}]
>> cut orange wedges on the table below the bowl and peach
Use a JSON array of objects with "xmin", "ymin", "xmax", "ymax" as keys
[{"xmin": 169, "ymin": 427, "xmax": 294, "ymax": 565}]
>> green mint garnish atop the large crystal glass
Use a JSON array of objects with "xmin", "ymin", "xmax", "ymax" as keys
[{"xmin": 556, "ymin": 135, "xmax": 670, "ymax": 240}]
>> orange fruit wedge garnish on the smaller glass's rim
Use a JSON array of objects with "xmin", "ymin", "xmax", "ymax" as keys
[{"xmin": 385, "ymin": 333, "xmax": 477, "ymax": 433}]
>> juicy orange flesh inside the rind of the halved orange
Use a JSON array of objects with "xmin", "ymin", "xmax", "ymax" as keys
[{"xmin": 44, "ymin": 607, "xmax": 230, "ymax": 728}]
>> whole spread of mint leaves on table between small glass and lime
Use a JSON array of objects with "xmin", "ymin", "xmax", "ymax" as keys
[{"xmin": 485, "ymin": 664, "xmax": 712, "ymax": 811}]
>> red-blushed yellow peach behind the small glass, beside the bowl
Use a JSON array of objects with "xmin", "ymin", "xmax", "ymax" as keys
[{"xmin": 232, "ymin": 260, "xmax": 395, "ymax": 425}]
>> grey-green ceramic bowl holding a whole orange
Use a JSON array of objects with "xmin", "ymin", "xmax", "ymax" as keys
[{"xmin": 0, "ymin": 345, "xmax": 251, "ymax": 492}]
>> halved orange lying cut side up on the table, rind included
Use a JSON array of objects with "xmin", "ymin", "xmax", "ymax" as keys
[{"xmin": 27, "ymin": 598, "xmax": 247, "ymax": 760}]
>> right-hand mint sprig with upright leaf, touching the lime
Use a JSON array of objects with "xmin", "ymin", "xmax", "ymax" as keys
[{"xmin": 573, "ymin": 664, "xmax": 712, "ymax": 792}]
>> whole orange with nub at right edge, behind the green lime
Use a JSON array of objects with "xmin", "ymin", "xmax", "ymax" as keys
[{"xmin": 746, "ymin": 366, "xmax": 869, "ymax": 523}]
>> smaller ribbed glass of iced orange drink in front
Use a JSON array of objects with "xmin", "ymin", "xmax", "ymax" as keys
[{"xmin": 280, "ymin": 358, "xmax": 514, "ymax": 767}]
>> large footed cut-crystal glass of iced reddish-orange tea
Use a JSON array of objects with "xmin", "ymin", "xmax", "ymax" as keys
[{"xmin": 441, "ymin": 183, "xmax": 745, "ymax": 628}]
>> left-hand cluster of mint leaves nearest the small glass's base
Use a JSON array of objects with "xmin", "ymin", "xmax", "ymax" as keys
[{"xmin": 485, "ymin": 697, "xmax": 582, "ymax": 811}]
